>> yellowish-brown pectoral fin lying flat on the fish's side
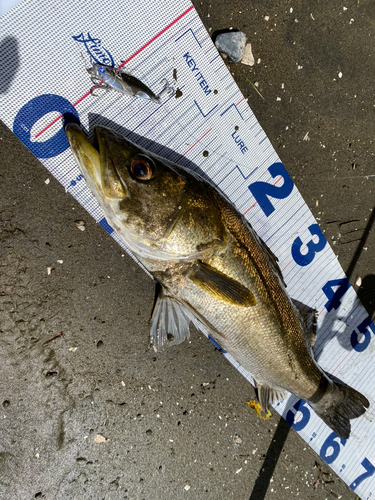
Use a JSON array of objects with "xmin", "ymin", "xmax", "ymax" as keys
[{"xmin": 187, "ymin": 261, "xmax": 256, "ymax": 307}]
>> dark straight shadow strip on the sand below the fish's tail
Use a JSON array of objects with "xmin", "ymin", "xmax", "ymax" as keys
[{"xmin": 249, "ymin": 417, "xmax": 290, "ymax": 500}]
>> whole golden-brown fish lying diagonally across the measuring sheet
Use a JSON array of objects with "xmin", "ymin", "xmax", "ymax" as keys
[{"xmin": 66, "ymin": 124, "xmax": 369, "ymax": 439}]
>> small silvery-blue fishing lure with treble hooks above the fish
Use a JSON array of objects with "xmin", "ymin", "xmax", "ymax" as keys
[{"xmin": 86, "ymin": 57, "xmax": 174, "ymax": 103}]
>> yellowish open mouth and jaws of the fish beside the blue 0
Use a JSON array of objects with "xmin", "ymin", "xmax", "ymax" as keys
[{"xmin": 65, "ymin": 123, "xmax": 131, "ymax": 200}]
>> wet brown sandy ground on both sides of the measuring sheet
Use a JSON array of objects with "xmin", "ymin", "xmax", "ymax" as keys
[{"xmin": 0, "ymin": 0, "xmax": 375, "ymax": 500}]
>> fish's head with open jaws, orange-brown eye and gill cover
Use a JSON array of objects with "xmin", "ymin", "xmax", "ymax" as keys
[{"xmin": 65, "ymin": 123, "xmax": 221, "ymax": 259}]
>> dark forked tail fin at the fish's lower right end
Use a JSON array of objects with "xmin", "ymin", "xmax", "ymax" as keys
[{"xmin": 312, "ymin": 381, "xmax": 370, "ymax": 439}]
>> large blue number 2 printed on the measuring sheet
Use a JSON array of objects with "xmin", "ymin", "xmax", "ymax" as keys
[{"xmin": 249, "ymin": 162, "xmax": 294, "ymax": 217}]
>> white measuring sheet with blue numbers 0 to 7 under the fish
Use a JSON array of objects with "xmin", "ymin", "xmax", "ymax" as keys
[{"xmin": 0, "ymin": 0, "xmax": 375, "ymax": 499}]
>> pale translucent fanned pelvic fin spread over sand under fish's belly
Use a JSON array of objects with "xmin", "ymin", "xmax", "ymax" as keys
[{"xmin": 150, "ymin": 289, "xmax": 190, "ymax": 351}]
